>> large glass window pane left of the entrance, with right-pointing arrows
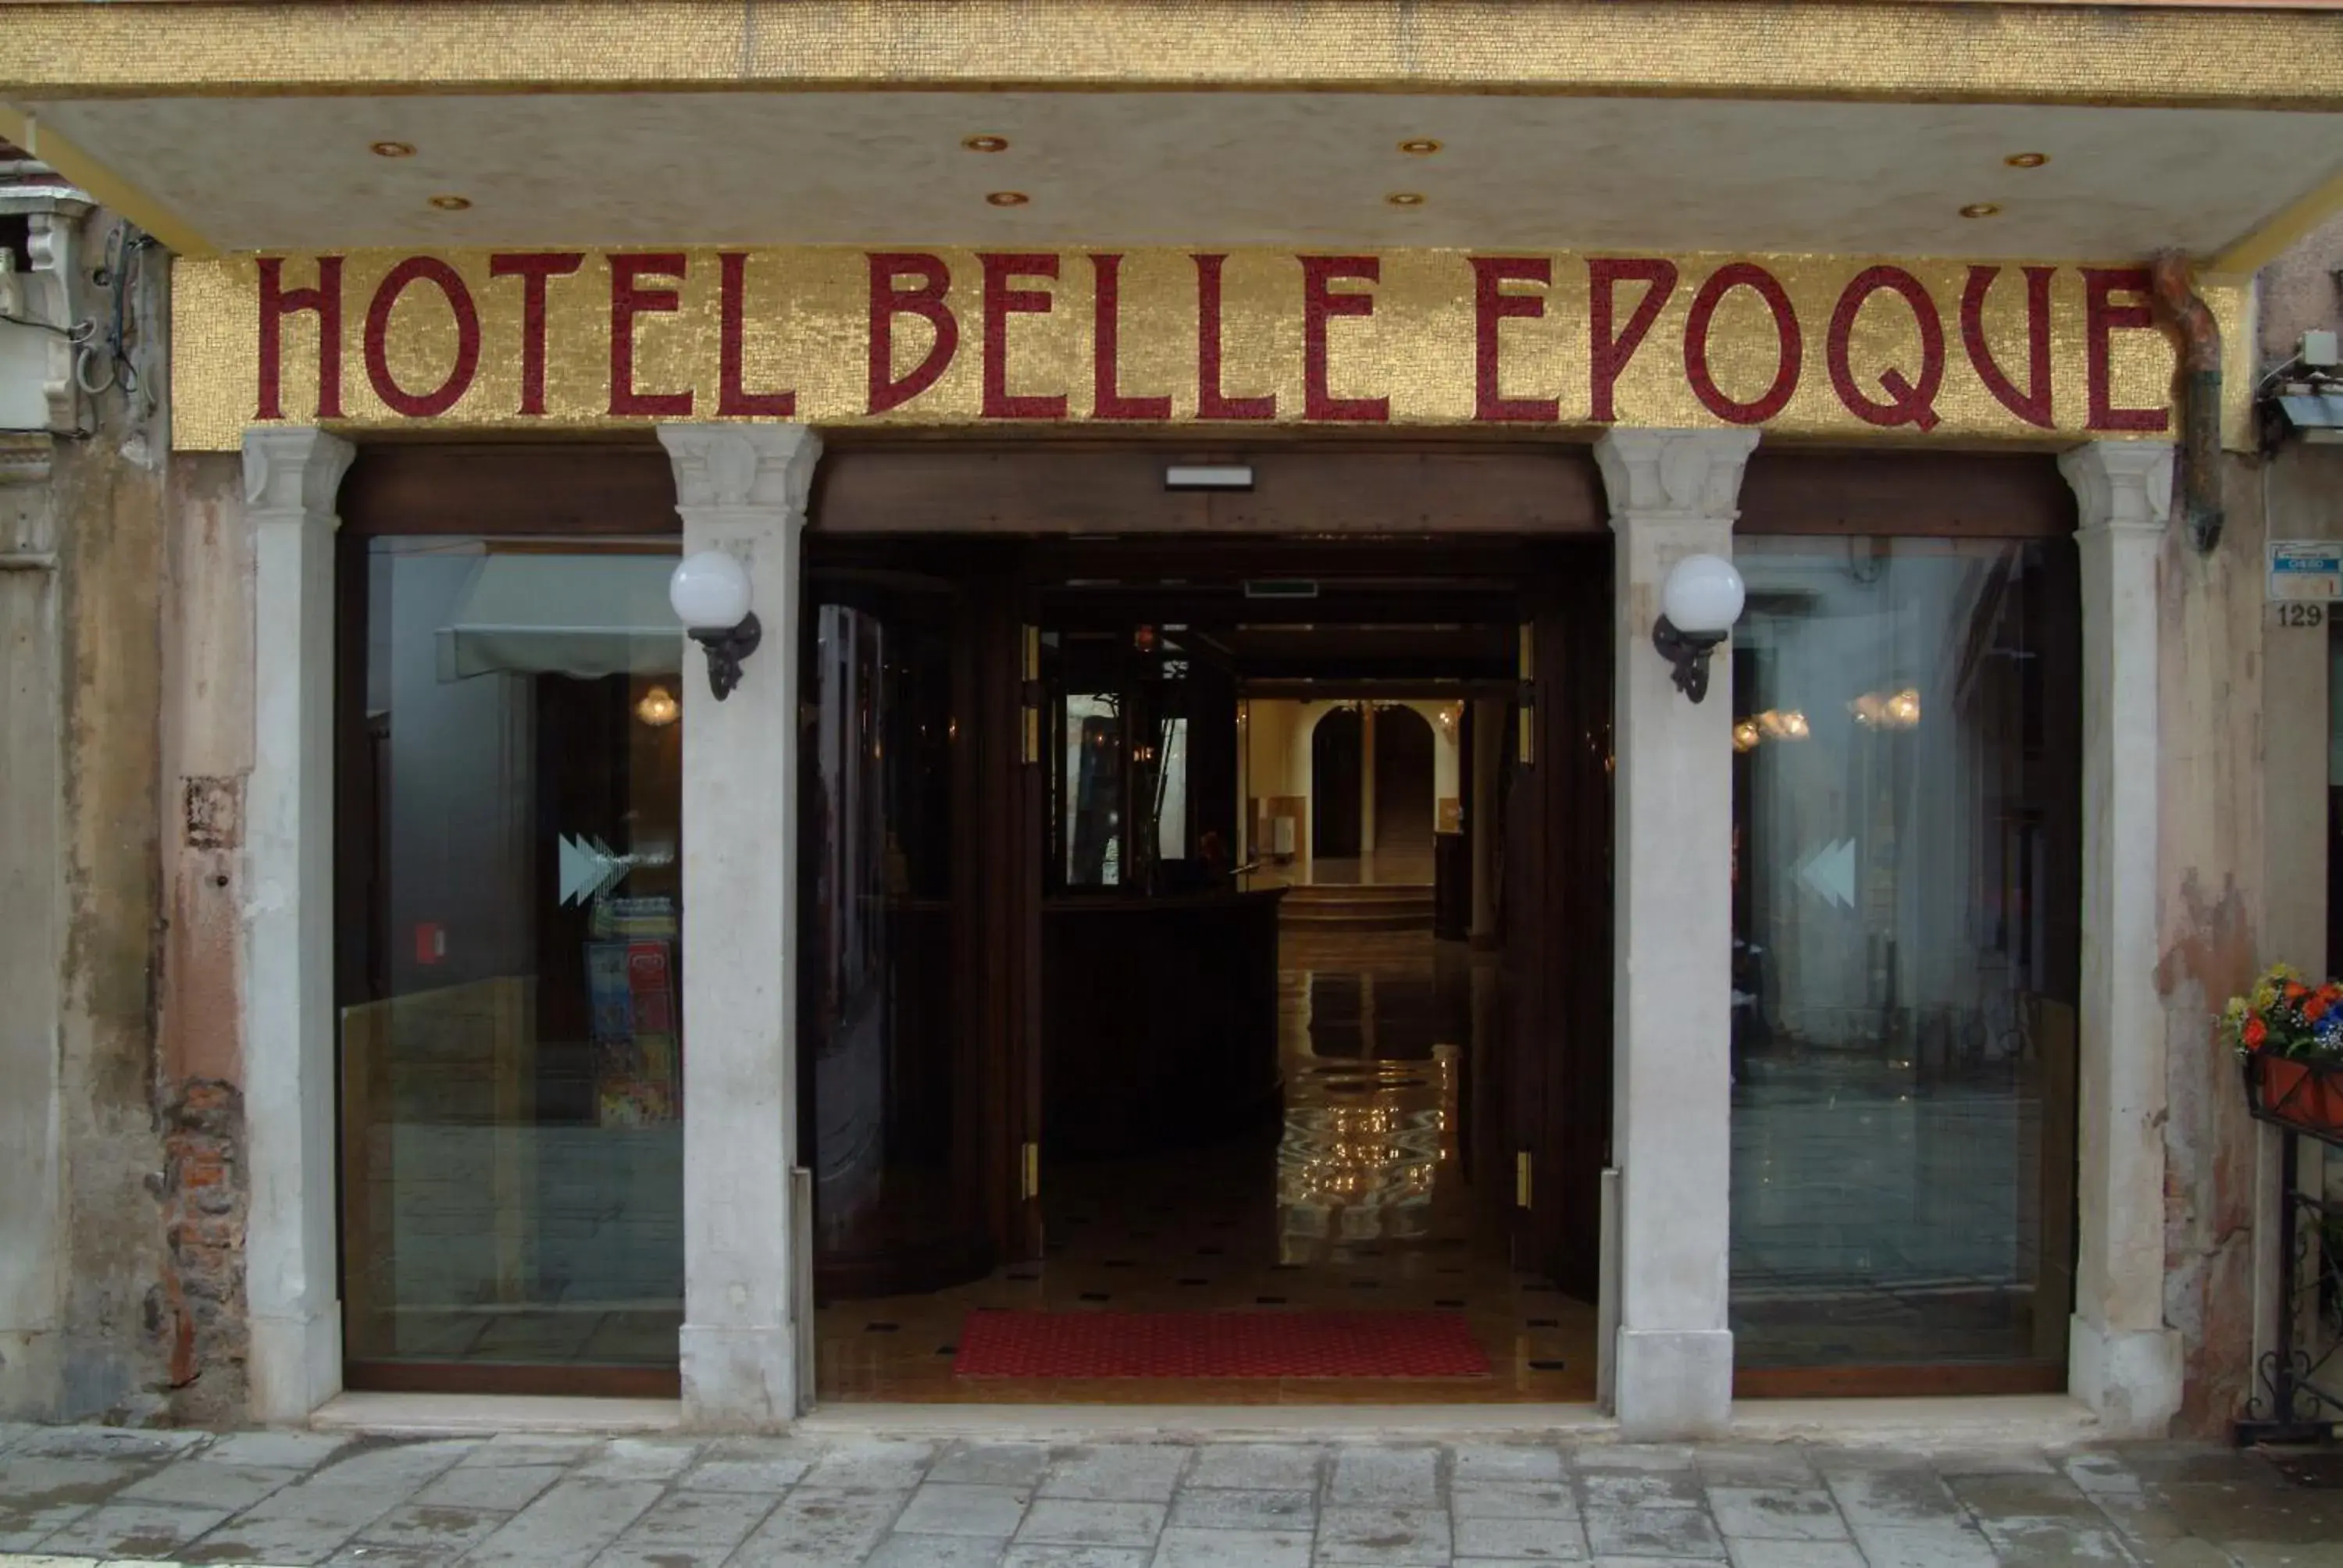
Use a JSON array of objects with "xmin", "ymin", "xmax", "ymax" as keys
[{"xmin": 337, "ymin": 536, "xmax": 691, "ymax": 1392}]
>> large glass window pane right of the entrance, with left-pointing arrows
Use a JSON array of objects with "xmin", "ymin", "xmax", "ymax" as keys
[{"xmin": 1731, "ymin": 536, "xmax": 2081, "ymax": 1392}]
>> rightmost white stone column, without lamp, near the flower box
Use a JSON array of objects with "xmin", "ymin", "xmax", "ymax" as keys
[{"xmin": 2059, "ymin": 440, "xmax": 2181, "ymax": 1437}]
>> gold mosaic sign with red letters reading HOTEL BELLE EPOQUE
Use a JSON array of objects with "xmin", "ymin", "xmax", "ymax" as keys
[{"xmin": 173, "ymin": 246, "xmax": 2245, "ymax": 450}]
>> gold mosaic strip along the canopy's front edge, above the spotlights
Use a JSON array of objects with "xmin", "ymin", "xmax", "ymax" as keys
[{"xmin": 13, "ymin": 0, "xmax": 2343, "ymax": 108}]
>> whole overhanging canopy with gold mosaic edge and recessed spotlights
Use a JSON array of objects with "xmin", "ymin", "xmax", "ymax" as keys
[{"xmin": 0, "ymin": 0, "xmax": 2343, "ymax": 265}]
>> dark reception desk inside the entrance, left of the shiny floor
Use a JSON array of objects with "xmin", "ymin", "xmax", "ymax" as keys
[{"xmin": 1040, "ymin": 886, "xmax": 1284, "ymax": 1158}]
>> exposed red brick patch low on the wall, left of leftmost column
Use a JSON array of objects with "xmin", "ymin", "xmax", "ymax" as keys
[{"xmin": 150, "ymin": 1078, "xmax": 251, "ymax": 1425}]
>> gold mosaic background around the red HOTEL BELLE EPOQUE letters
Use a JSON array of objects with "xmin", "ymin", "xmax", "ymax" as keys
[{"xmin": 173, "ymin": 248, "xmax": 2245, "ymax": 450}]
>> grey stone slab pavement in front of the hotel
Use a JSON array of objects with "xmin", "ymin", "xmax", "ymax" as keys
[{"xmin": 0, "ymin": 1427, "xmax": 2343, "ymax": 1568}]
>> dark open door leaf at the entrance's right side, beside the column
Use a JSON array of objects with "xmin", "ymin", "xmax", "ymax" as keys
[{"xmin": 1502, "ymin": 546, "xmax": 1612, "ymax": 1301}]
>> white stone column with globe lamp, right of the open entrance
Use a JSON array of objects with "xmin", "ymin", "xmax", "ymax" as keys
[{"xmin": 1596, "ymin": 429, "xmax": 1757, "ymax": 1439}]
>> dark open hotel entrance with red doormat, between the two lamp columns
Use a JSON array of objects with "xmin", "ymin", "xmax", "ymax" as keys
[{"xmin": 799, "ymin": 520, "xmax": 1612, "ymax": 1404}]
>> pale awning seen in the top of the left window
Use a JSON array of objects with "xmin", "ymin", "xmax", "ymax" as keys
[{"xmin": 438, "ymin": 555, "xmax": 684, "ymax": 679}]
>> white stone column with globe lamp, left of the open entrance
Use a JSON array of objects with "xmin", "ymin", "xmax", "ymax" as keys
[{"xmin": 658, "ymin": 424, "xmax": 822, "ymax": 1432}]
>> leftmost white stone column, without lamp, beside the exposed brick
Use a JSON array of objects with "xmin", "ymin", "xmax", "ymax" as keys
[{"xmin": 244, "ymin": 426, "xmax": 356, "ymax": 1423}]
